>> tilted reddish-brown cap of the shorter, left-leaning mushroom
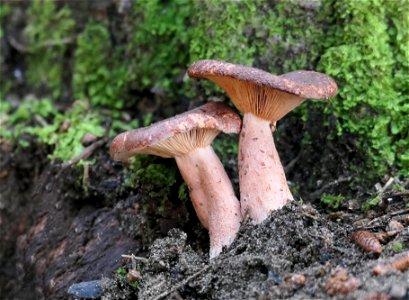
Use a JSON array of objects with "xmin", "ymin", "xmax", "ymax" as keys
[{"xmin": 110, "ymin": 102, "xmax": 241, "ymax": 161}]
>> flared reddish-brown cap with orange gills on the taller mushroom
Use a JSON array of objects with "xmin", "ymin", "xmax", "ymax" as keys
[{"xmin": 188, "ymin": 60, "xmax": 337, "ymax": 122}]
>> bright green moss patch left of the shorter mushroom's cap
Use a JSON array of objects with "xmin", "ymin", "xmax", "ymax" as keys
[{"xmin": 0, "ymin": 99, "xmax": 105, "ymax": 161}]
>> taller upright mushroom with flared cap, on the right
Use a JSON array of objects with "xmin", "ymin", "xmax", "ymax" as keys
[{"xmin": 188, "ymin": 60, "xmax": 337, "ymax": 223}]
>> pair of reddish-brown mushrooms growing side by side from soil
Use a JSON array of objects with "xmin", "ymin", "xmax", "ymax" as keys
[{"xmin": 110, "ymin": 60, "xmax": 337, "ymax": 258}]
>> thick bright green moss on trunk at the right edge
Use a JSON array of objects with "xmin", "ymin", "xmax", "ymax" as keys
[{"xmin": 319, "ymin": 0, "xmax": 409, "ymax": 176}]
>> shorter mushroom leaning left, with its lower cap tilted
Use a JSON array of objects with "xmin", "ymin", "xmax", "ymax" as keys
[{"xmin": 110, "ymin": 102, "xmax": 242, "ymax": 258}]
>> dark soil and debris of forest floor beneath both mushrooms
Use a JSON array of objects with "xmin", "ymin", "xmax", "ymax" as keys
[{"xmin": 0, "ymin": 141, "xmax": 409, "ymax": 299}]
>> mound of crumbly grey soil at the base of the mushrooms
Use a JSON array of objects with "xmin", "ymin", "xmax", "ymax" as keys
[{"xmin": 128, "ymin": 203, "xmax": 409, "ymax": 299}]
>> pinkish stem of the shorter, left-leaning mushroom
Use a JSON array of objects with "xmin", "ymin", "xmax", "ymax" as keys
[{"xmin": 175, "ymin": 146, "xmax": 242, "ymax": 258}]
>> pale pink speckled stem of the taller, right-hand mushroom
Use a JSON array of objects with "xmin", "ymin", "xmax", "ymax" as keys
[{"xmin": 239, "ymin": 113, "xmax": 293, "ymax": 223}]
